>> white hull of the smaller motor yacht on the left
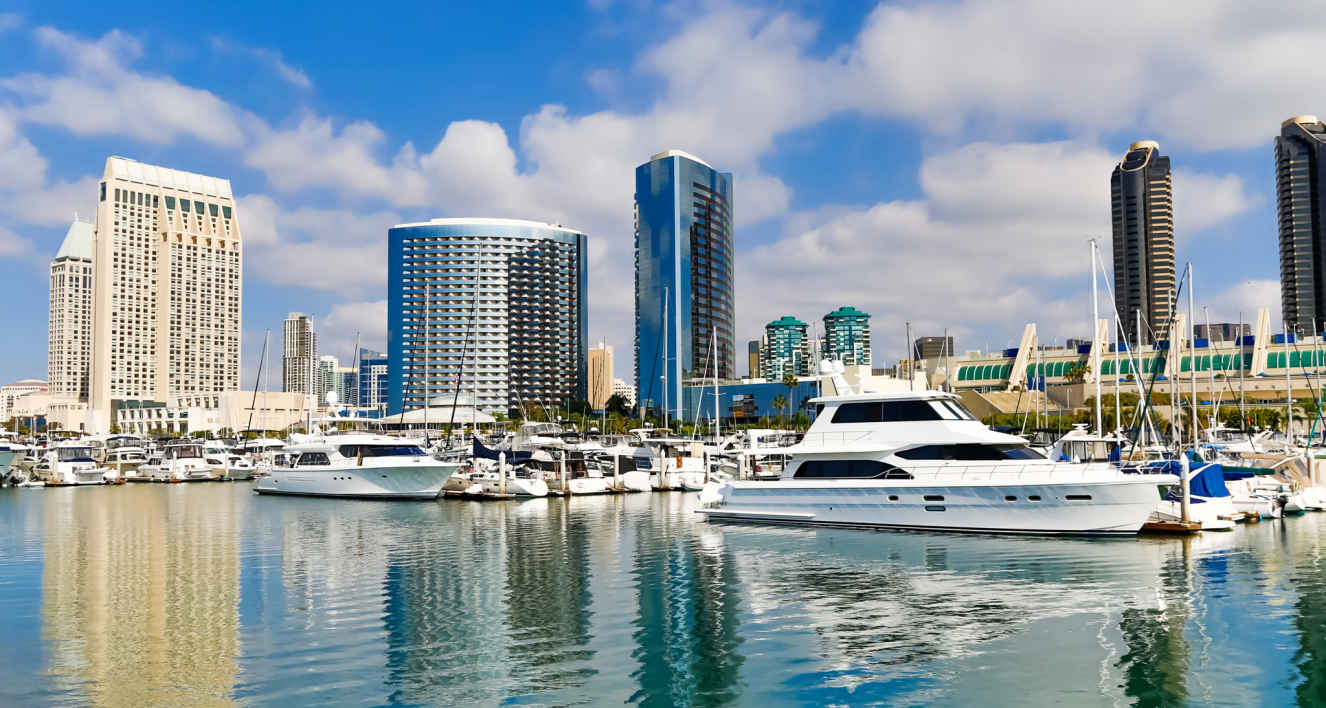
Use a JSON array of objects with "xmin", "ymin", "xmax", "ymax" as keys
[{"xmin": 253, "ymin": 464, "xmax": 460, "ymax": 500}]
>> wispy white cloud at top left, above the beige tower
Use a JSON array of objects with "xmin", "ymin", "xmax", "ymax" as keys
[{"xmin": 0, "ymin": 27, "xmax": 257, "ymax": 147}]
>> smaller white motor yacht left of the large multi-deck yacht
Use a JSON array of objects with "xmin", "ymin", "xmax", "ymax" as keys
[{"xmin": 253, "ymin": 432, "xmax": 460, "ymax": 499}]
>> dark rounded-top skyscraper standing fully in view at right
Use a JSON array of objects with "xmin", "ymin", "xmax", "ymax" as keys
[{"xmin": 1110, "ymin": 141, "xmax": 1175, "ymax": 342}]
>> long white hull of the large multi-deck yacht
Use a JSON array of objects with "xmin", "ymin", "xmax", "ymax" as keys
[{"xmin": 697, "ymin": 477, "xmax": 1175, "ymax": 536}]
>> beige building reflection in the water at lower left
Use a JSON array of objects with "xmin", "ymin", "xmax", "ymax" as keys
[{"xmin": 41, "ymin": 487, "xmax": 244, "ymax": 707}]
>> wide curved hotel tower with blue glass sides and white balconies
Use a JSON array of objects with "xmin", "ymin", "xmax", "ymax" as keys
[{"xmin": 387, "ymin": 219, "xmax": 587, "ymax": 415}]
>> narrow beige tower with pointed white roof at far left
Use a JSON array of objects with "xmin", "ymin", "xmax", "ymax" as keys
[{"xmin": 46, "ymin": 219, "xmax": 94, "ymax": 400}]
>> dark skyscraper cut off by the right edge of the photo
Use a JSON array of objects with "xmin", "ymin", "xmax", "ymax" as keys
[{"xmin": 1276, "ymin": 115, "xmax": 1326, "ymax": 334}]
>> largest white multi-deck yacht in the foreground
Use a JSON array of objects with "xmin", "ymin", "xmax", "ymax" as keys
[{"xmin": 700, "ymin": 382, "xmax": 1179, "ymax": 534}]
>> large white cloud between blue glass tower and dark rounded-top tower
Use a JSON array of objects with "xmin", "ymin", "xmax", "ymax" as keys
[{"xmin": 737, "ymin": 142, "xmax": 1260, "ymax": 361}]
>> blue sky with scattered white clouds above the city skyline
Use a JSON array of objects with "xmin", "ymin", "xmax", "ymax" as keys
[{"xmin": 0, "ymin": 0, "xmax": 1304, "ymax": 389}]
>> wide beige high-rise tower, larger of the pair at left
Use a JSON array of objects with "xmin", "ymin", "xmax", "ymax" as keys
[{"xmin": 89, "ymin": 156, "xmax": 243, "ymax": 432}]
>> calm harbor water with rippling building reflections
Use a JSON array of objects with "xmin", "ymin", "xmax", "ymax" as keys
[{"xmin": 0, "ymin": 484, "xmax": 1326, "ymax": 708}]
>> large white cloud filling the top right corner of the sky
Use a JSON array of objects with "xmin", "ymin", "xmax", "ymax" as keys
[{"xmin": 851, "ymin": 0, "xmax": 1326, "ymax": 148}]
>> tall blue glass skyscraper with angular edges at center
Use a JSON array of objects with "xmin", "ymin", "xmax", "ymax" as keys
[{"xmin": 635, "ymin": 150, "xmax": 736, "ymax": 416}]
